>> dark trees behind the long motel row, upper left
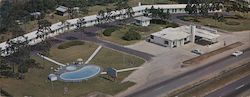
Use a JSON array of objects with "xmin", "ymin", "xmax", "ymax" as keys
[{"xmin": 0, "ymin": 0, "xmax": 121, "ymax": 36}]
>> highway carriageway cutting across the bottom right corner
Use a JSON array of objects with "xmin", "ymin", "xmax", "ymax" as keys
[{"xmin": 205, "ymin": 71, "xmax": 250, "ymax": 97}]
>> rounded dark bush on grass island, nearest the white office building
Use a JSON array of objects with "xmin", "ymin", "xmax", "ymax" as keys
[{"xmin": 122, "ymin": 31, "xmax": 141, "ymax": 41}]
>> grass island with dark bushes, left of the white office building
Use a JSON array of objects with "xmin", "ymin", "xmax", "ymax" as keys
[{"xmin": 101, "ymin": 24, "xmax": 166, "ymax": 45}]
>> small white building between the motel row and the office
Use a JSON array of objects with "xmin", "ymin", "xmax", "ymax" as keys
[{"xmin": 135, "ymin": 16, "xmax": 151, "ymax": 26}]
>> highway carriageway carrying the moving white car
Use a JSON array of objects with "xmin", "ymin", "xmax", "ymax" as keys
[{"xmin": 126, "ymin": 49, "xmax": 250, "ymax": 97}]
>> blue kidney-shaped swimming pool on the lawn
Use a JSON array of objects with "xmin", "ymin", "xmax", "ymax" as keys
[{"xmin": 60, "ymin": 65, "xmax": 101, "ymax": 82}]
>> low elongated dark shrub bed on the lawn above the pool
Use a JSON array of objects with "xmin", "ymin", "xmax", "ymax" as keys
[{"xmin": 57, "ymin": 41, "xmax": 84, "ymax": 49}]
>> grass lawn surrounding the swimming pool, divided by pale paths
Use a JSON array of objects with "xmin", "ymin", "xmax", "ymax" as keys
[{"xmin": 0, "ymin": 42, "xmax": 144, "ymax": 97}]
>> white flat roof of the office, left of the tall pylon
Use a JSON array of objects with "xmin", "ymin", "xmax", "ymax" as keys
[{"xmin": 151, "ymin": 26, "xmax": 190, "ymax": 41}]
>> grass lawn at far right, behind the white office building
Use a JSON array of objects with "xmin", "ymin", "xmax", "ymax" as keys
[{"xmin": 180, "ymin": 13, "xmax": 250, "ymax": 31}]
